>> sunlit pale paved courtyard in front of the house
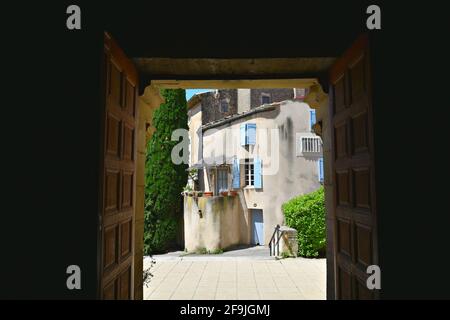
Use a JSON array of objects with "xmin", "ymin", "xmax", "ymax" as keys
[{"xmin": 144, "ymin": 248, "xmax": 326, "ymax": 300}]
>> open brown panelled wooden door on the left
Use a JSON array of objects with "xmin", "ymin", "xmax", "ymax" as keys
[{"xmin": 99, "ymin": 33, "xmax": 138, "ymax": 299}]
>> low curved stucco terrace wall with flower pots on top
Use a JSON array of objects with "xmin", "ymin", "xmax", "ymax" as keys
[{"xmin": 184, "ymin": 196, "xmax": 250, "ymax": 252}]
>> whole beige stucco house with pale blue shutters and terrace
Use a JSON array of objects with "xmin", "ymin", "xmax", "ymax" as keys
[{"xmin": 184, "ymin": 88, "xmax": 323, "ymax": 251}]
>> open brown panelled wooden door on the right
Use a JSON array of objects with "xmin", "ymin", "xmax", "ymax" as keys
[{"xmin": 330, "ymin": 35, "xmax": 378, "ymax": 299}]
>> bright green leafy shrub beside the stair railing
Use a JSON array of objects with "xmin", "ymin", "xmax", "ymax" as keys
[{"xmin": 282, "ymin": 187, "xmax": 326, "ymax": 257}]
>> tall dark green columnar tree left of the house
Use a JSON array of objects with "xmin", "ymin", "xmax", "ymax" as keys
[{"xmin": 144, "ymin": 89, "xmax": 188, "ymax": 254}]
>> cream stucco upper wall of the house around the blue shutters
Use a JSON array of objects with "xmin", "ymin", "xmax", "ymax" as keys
[{"xmin": 203, "ymin": 101, "xmax": 321, "ymax": 244}]
